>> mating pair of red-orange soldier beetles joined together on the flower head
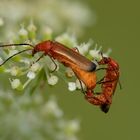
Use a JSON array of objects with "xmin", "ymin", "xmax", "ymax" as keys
[{"xmin": 0, "ymin": 40, "xmax": 120, "ymax": 113}]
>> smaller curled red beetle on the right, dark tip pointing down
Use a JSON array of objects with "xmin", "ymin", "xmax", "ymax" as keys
[{"xmin": 85, "ymin": 56, "xmax": 121, "ymax": 113}]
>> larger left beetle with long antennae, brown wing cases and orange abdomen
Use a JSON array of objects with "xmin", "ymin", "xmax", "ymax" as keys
[{"xmin": 0, "ymin": 40, "xmax": 96, "ymax": 90}]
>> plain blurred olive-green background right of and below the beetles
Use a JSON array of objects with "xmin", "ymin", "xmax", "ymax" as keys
[{"xmin": 0, "ymin": 0, "xmax": 140, "ymax": 140}]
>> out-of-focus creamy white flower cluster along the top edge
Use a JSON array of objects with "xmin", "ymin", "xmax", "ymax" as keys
[{"xmin": 0, "ymin": 0, "xmax": 96, "ymax": 35}]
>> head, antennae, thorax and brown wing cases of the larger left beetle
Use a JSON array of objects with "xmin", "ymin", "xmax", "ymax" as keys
[{"xmin": 0, "ymin": 40, "xmax": 96, "ymax": 71}]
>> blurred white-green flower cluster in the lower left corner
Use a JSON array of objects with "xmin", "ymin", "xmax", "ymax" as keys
[{"xmin": 0, "ymin": 91, "xmax": 80, "ymax": 140}]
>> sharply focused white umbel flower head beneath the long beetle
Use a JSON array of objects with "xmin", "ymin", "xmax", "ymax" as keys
[{"xmin": 0, "ymin": 21, "xmax": 110, "ymax": 91}]
